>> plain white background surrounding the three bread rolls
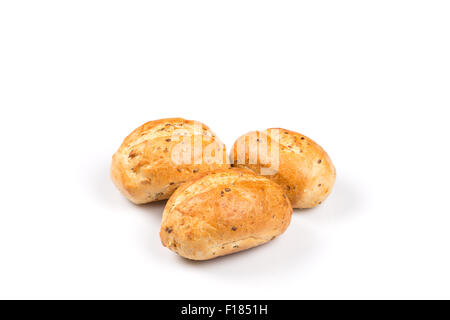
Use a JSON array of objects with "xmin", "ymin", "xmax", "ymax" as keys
[{"xmin": 0, "ymin": 0, "xmax": 450, "ymax": 299}]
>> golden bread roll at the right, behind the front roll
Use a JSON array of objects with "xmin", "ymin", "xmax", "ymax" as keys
[{"xmin": 231, "ymin": 128, "xmax": 336, "ymax": 208}]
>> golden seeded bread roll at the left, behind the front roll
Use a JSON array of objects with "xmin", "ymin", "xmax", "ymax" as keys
[{"xmin": 111, "ymin": 118, "xmax": 230, "ymax": 204}]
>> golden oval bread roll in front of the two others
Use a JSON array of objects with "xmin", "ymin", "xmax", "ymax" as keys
[{"xmin": 160, "ymin": 168, "xmax": 292, "ymax": 260}]
